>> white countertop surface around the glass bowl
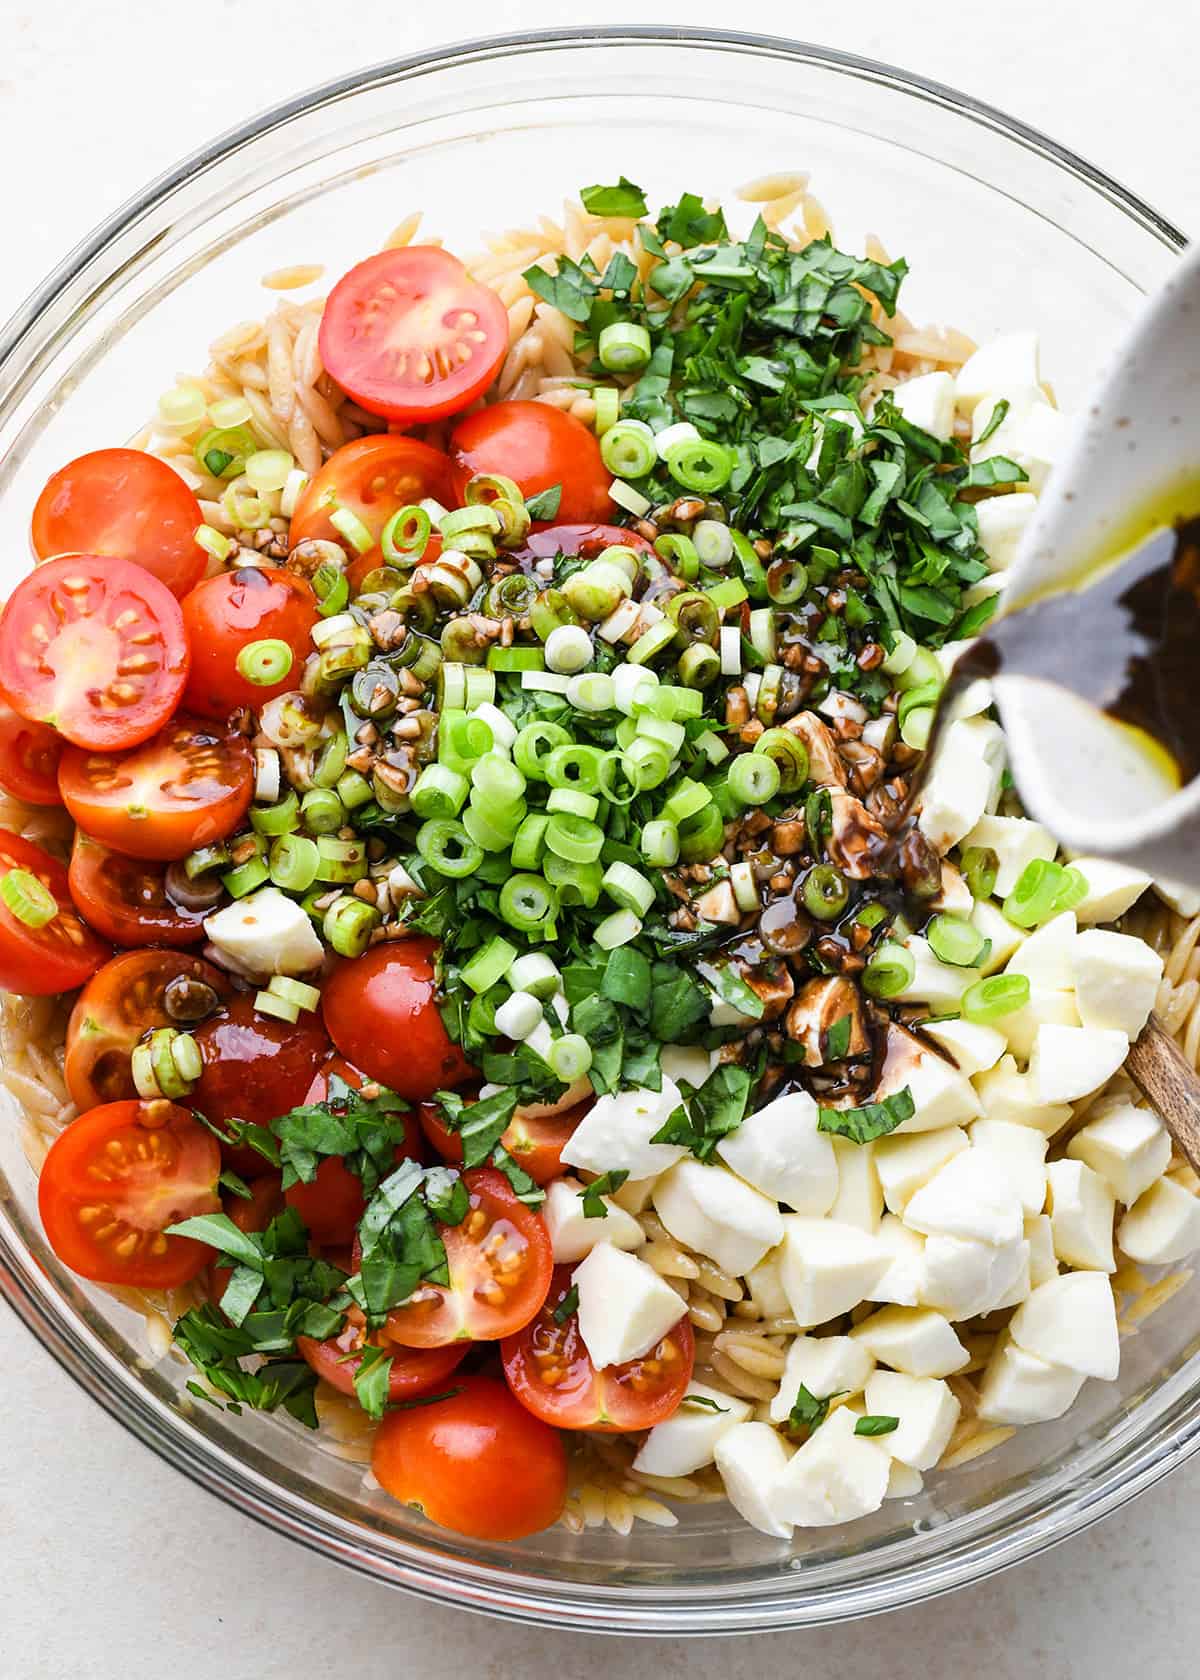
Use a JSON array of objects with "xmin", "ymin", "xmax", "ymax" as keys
[{"xmin": 0, "ymin": 0, "xmax": 1200, "ymax": 1680}]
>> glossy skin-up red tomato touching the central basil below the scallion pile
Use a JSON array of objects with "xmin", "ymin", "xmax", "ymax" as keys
[{"xmin": 321, "ymin": 939, "xmax": 471, "ymax": 1102}]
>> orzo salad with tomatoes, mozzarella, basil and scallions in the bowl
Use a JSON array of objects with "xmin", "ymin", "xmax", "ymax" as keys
[{"xmin": 0, "ymin": 178, "xmax": 1200, "ymax": 1541}]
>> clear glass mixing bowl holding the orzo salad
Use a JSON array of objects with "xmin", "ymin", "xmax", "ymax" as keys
[{"xmin": 0, "ymin": 30, "xmax": 1200, "ymax": 1635}]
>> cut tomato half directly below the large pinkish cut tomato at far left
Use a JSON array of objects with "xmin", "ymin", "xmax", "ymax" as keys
[{"xmin": 59, "ymin": 714, "xmax": 254, "ymax": 860}]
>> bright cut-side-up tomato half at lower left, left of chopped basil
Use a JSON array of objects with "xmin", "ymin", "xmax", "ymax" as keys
[{"xmin": 37, "ymin": 1100, "xmax": 220, "ymax": 1289}]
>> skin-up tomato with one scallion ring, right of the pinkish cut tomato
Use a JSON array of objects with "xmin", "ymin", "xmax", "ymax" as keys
[{"xmin": 183, "ymin": 566, "xmax": 318, "ymax": 717}]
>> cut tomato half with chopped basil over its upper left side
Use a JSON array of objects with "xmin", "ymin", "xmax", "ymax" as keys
[{"xmin": 371, "ymin": 1166, "xmax": 553, "ymax": 1347}]
